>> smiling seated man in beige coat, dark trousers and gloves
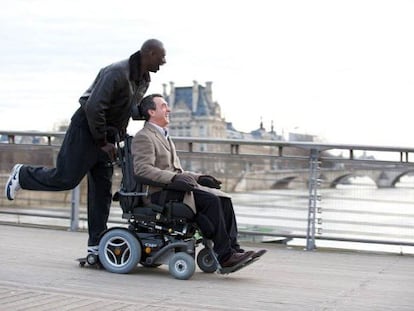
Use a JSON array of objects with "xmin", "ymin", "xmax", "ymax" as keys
[{"xmin": 131, "ymin": 94, "xmax": 265, "ymax": 267}]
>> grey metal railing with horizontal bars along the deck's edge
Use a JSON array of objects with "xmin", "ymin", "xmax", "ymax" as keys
[{"xmin": 0, "ymin": 131, "xmax": 414, "ymax": 250}]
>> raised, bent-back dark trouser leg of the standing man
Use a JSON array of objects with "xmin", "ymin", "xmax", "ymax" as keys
[{"xmin": 19, "ymin": 111, "xmax": 99, "ymax": 191}]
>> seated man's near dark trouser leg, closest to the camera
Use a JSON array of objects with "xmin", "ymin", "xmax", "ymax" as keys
[{"xmin": 193, "ymin": 189, "xmax": 233, "ymax": 261}]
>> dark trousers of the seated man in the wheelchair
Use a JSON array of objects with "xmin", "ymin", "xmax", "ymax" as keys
[{"xmin": 151, "ymin": 189, "xmax": 240, "ymax": 261}]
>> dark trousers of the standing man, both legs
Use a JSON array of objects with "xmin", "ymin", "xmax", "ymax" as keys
[{"xmin": 19, "ymin": 108, "xmax": 113, "ymax": 246}]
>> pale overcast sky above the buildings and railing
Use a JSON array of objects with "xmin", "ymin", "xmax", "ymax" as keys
[{"xmin": 0, "ymin": 0, "xmax": 414, "ymax": 147}]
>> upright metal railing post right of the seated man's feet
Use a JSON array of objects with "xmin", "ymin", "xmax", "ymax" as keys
[{"xmin": 306, "ymin": 149, "xmax": 321, "ymax": 251}]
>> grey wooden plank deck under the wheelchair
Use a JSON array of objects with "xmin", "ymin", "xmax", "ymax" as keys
[{"xmin": 0, "ymin": 225, "xmax": 414, "ymax": 311}]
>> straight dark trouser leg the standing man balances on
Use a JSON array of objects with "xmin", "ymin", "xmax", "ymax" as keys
[{"xmin": 88, "ymin": 151, "xmax": 114, "ymax": 246}]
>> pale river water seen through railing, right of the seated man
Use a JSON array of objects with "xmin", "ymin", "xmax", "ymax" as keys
[{"xmin": 232, "ymin": 177, "xmax": 414, "ymax": 254}]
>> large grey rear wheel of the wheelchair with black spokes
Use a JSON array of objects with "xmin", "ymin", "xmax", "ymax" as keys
[{"xmin": 99, "ymin": 229, "xmax": 141, "ymax": 273}]
